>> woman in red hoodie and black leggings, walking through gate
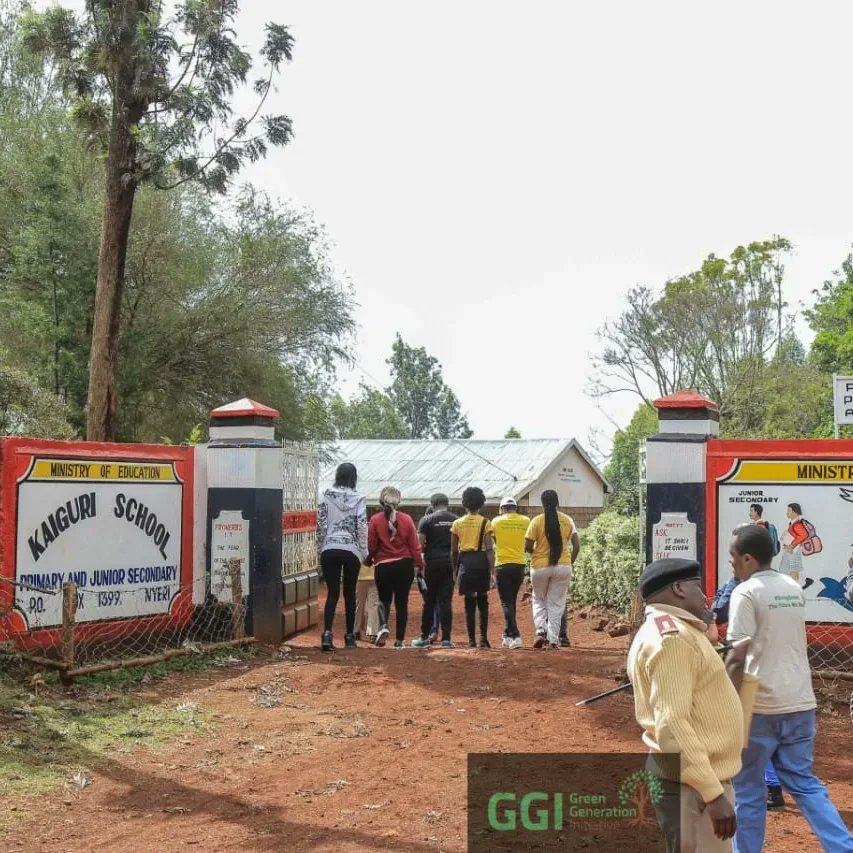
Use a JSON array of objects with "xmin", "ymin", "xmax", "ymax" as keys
[{"xmin": 367, "ymin": 486, "xmax": 424, "ymax": 649}]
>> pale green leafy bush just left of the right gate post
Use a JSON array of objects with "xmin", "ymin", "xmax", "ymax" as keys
[{"xmin": 570, "ymin": 510, "xmax": 642, "ymax": 613}]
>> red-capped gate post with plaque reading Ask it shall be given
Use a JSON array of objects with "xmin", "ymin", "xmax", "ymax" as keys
[{"xmin": 645, "ymin": 391, "xmax": 720, "ymax": 593}]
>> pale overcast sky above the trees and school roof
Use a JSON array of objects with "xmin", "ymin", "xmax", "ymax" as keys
[{"xmin": 55, "ymin": 0, "xmax": 853, "ymax": 452}]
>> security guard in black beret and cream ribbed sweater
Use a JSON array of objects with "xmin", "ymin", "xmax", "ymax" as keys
[{"xmin": 628, "ymin": 559, "xmax": 743, "ymax": 853}]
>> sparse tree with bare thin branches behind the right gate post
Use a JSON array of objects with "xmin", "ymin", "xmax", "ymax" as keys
[{"xmin": 595, "ymin": 237, "xmax": 791, "ymax": 426}]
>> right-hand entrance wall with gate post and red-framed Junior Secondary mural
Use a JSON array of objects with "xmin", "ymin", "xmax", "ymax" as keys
[{"xmin": 644, "ymin": 391, "xmax": 853, "ymax": 672}]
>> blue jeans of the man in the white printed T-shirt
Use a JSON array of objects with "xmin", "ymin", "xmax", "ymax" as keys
[{"xmin": 732, "ymin": 711, "xmax": 853, "ymax": 853}]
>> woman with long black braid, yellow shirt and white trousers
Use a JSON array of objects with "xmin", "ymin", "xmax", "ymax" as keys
[{"xmin": 524, "ymin": 489, "xmax": 580, "ymax": 649}]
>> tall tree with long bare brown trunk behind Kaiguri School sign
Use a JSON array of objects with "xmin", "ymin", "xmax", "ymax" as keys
[{"xmin": 23, "ymin": 0, "xmax": 292, "ymax": 441}]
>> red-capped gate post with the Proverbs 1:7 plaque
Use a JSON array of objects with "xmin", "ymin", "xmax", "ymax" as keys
[{"xmin": 207, "ymin": 398, "xmax": 283, "ymax": 644}]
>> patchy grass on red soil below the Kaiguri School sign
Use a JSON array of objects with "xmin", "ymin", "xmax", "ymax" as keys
[{"xmin": 0, "ymin": 646, "xmax": 259, "ymax": 833}]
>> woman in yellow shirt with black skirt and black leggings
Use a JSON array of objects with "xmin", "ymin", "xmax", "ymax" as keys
[{"xmin": 450, "ymin": 486, "xmax": 495, "ymax": 649}]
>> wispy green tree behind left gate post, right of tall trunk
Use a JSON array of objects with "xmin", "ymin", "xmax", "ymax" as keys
[{"xmin": 113, "ymin": 186, "xmax": 354, "ymax": 441}]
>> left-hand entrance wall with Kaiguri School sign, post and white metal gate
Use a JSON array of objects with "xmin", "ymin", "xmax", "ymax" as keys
[{"xmin": 0, "ymin": 399, "xmax": 319, "ymax": 677}]
